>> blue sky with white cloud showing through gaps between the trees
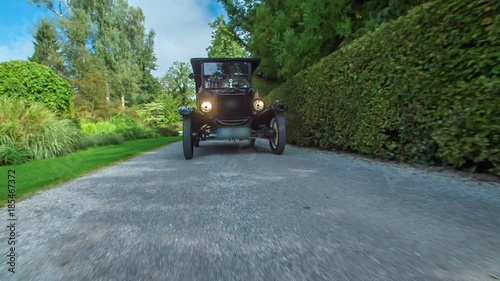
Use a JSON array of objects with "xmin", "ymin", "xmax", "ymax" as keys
[{"xmin": 0, "ymin": 0, "xmax": 223, "ymax": 76}]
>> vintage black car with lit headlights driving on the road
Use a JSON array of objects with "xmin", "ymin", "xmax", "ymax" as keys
[{"xmin": 179, "ymin": 58, "xmax": 286, "ymax": 159}]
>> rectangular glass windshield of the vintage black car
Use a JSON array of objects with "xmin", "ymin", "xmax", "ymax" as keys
[{"xmin": 203, "ymin": 61, "xmax": 250, "ymax": 88}]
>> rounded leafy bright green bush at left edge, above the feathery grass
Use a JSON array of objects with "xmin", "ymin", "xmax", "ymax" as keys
[{"xmin": 0, "ymin": 61, "xmax": 73, "ymax": 117}]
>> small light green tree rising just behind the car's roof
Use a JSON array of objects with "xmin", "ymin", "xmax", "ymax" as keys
[{"xmin": 206, "ymin": 15, "xmax": 247, "ymax": 58}]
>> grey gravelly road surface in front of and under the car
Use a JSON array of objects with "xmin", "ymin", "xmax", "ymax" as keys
[{"xmin": 0, "ymin": 141, "xmax": 500, "ymax": 281}]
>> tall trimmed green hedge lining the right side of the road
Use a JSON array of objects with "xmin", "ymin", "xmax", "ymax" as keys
[{"xmin": 266, "ymin": 0, "xmax": 500, "ymax": 175}]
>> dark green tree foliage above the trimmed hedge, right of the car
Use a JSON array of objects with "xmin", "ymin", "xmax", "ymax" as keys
[{"xmin": 219, "ymin": 0, "xmax": 426, "ymax": 80}]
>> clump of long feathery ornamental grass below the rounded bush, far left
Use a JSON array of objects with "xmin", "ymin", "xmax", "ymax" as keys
[{"xmin": 0, "ymin": 97, "xmax": 80, "ymax": 165}]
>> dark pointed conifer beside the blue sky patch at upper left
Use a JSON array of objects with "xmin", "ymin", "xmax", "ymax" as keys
[{"xmin": 29, "ymin": 19, "xmax": 65, "ymax": 75}]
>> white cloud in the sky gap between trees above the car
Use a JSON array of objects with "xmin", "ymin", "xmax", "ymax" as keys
[{"xmin": 129, "ymin": 0, "xmax": 221, "ymax": 76}]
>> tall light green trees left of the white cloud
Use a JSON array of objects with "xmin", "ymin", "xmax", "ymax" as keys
[{"xmin": 30, "ymin": 0, "xmax": 161, "ymax": 118}]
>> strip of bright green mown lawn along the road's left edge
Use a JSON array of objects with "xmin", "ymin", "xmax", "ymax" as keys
[{"xmin": 0, "ymin": 137, "xmax": 181, "ymax": 203}]
